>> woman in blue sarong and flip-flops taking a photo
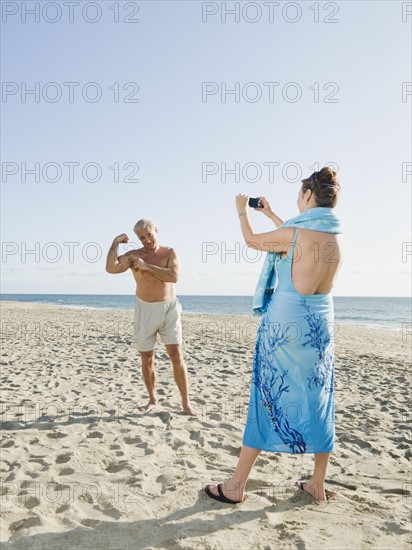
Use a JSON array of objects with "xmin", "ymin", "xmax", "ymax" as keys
[{"xmin": 205, "ymin": 167, "xmax": 341, "ymax": 504}]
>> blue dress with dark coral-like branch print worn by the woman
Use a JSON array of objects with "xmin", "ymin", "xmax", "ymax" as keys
[{"xmin": 243, "ymin": 228, "xmax": 335, "ymax": 454}]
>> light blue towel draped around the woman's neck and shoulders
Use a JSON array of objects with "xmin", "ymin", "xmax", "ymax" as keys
[{"xmin": 252, "ymin": 206, "xmax": 342, "ymax": 315}]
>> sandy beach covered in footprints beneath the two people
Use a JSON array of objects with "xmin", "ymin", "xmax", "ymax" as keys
[{"xmin": 1, "ymin": 302, "xmax": 412, "ymax": 550}]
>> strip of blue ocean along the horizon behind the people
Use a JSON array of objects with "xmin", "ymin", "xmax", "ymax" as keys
[{"xmin": 0, "ymin": 294, "xmax": 412, "ymax": 330}]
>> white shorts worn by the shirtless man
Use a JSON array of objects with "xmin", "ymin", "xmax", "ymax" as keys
[{"xmin": 132, "ymin": 297, "xmax": 182, "ymax": 351}]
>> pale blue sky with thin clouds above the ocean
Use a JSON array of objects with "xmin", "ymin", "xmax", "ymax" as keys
[{"xmin": 1, "ymin": 0, "xmax": 412, "ymax": 296}]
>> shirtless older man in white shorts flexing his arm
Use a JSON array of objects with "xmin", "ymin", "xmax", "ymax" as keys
[{"xmin": 106, "ymin": 219, "xmax": 198, "ymax": 416}]
